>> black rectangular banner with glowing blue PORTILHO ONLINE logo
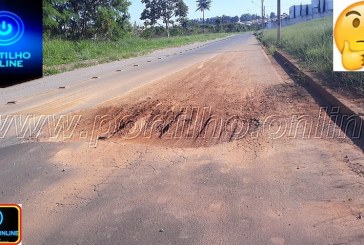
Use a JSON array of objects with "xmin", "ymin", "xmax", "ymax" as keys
[{"xmin": 0, "ymin": 0, "xmax": 43, "ymax": 87}]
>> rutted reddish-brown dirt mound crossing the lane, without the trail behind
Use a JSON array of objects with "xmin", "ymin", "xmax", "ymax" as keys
[{"xmin": 77, "ymin": 94, "xmax": 261, "ymax": 146}]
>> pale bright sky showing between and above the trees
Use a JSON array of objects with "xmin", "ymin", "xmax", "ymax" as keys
[{"xmin": 129, "ymin": 0, "xmax": 311, "ymax": 24}]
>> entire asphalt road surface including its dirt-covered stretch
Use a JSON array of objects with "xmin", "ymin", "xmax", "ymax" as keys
[{"xmin": 0, "ymin": 34, "xmax": 364, "ymax": 245}]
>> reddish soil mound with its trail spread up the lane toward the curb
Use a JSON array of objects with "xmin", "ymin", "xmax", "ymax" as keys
[{"xmin": 47, "ymin": 48, "xmax": 344, "ymax": 147}]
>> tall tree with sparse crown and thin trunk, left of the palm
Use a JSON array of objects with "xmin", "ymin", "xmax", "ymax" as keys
[{"xmin": 140, "ymin": 0, "xmax": 188, "ymax": 37}]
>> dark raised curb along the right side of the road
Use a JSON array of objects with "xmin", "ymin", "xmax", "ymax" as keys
[{"xmin": 273, "ymin": 50, "xmax": 364, "ymax": 151}]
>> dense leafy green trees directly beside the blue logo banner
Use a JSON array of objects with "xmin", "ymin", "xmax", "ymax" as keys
[{"xmin": 43, "ymin": 0, "xmax": 131, "ymax": 39}]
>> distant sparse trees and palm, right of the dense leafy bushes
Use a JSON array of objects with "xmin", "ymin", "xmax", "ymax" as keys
[{"xmin": 134, "ymin": 0, "xmax": 260, "ymax": 38}]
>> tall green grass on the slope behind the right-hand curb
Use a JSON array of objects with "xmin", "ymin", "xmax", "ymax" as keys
[{"xmin": 258, "ymin": 17, "xmax": 364, "ymax": 95}]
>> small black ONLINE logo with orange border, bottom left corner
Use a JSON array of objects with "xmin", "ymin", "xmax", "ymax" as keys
[{"xmin": 0, "ymin": 204, "xmax": 22, "ymax": 245}]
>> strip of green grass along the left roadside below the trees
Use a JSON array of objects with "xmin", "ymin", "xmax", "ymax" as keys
[{"xmin": 43, "ymin": 33, "xmax": 231, "ymax": 75}]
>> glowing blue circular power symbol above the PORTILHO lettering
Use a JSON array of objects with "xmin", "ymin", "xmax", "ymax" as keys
[{"xmin": 0, "ymin": 11, "xmax": 24, "ymax": 46}]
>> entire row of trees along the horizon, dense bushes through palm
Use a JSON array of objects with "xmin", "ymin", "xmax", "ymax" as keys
[{"xmin": 43, "ymin": 0, "xmax": 260, "ymax": 40}]
